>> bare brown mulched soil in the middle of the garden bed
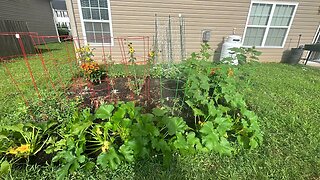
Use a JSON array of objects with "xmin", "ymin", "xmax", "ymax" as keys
[{"xmin": 68, "ymin": 77, "xmax": 184, "ymax": 112}]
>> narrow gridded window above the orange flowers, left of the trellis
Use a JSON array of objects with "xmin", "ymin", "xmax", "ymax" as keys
[{"xmin": 80, "ymin": 0, "xmax": 112, "ymax": 44}]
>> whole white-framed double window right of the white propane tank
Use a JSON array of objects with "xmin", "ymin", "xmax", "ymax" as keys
[{"xmin": 243, "ymin": 2, "xmax": 297, "ymax": 47}]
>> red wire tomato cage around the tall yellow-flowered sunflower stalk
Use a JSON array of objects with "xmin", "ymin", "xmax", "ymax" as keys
[{"xmin": 69, "ymin": 36, "xmax": 150, "ymax": 107}]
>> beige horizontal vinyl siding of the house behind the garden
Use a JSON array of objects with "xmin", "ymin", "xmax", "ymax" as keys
[{"xmin": 67, "ymin": 0, "xmax": 320, "ymax": 62}]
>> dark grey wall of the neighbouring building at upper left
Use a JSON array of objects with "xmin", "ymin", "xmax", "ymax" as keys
[{"xmin": 0, "ymin": 0, "xmax": 57, "ymax": 36}]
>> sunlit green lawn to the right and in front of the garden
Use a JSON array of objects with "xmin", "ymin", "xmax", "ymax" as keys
[{"xmin": 0, "ymin": 43, "xmax": 320, "ymax": 179}]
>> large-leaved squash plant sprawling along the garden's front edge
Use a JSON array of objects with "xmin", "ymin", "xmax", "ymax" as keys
[{"xmin": 46, "ymin": 102, "xmax": 191, "ymax": 179}]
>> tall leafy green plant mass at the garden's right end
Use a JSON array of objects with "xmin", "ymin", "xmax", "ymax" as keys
[{"xmin": 180, "ymin": 47, "xmax": 262, "ymax": 155}]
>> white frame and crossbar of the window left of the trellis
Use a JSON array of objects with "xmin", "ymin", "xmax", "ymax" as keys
[{"xmin": 77, "ymin": 0, "xmax": 114, "ymax": 47}]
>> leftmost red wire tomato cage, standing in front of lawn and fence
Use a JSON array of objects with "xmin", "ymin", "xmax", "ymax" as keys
[{"xmin": 0, "ymin": 32, "xmax": 75, "ymax": 105}]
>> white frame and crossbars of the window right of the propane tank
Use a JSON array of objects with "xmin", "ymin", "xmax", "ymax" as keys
[{"xmin": 241, "ymin": 0, "xmax": 299, "ymax": 49}]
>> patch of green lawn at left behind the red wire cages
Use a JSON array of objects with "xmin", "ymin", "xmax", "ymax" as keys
[{"xmin": 0, "ymin": 43, "xmax": 75, "ymax": 124}]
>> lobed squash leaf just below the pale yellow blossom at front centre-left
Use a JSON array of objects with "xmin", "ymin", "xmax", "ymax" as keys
[{"xmin": 97, "ymin": 147, "xmax": 121, "ymax": 170}]
